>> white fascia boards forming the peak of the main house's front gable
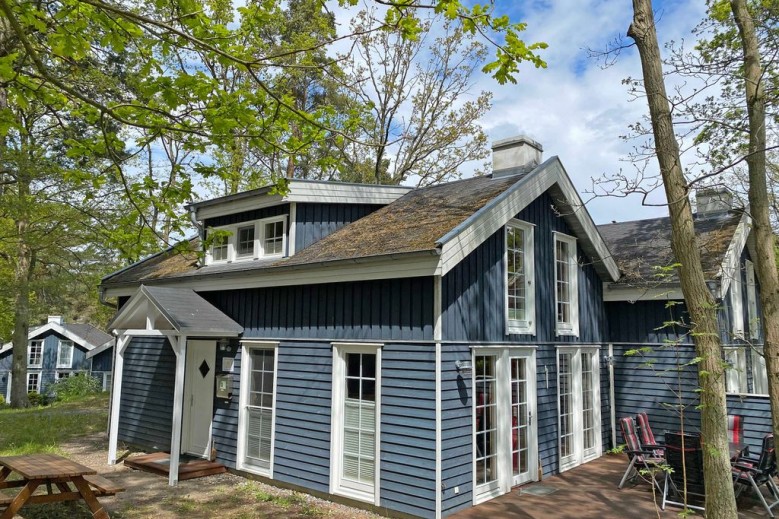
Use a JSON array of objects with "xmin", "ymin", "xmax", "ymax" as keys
[{"xmin": 439, "ymin": 157, "xmax": 619, "ymax": 281}]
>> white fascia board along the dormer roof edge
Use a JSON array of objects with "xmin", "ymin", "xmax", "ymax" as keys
[{"xmin": 195, "ymin": 180, "xmax": 413, "ymax": 221}]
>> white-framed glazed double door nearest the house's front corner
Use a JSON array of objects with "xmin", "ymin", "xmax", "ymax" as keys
[{"xmin": 473, "ymin": 348, "xmax": 538, "ymax": 503}]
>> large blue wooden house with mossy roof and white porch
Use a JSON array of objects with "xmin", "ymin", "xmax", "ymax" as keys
[{"xmin": 94, "ymin": 138, "xmax": 764, "ymax": 517}]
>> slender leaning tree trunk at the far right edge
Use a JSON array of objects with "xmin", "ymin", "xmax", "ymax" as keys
[{"xmin": 730, "ymin": 0, "xmax": 779, "ymax": 446}]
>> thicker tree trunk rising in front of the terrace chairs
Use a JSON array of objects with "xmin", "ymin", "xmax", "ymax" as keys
[{"xmin": 628, "ymin": 0, "xmax": 737, "ymax": 519}]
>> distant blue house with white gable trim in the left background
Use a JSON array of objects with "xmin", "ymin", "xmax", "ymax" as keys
[{"xmin": 0, "ymin": 315, "xmax": 114, "ymax": 400}]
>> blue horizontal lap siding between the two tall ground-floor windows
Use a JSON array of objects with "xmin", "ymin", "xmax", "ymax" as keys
[{"xmin": 273, "ymin": 342, "xmax": 333, "ymax": 492}]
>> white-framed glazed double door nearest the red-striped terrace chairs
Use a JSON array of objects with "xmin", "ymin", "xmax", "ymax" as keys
[{"xmin": 557, "ymin": 347, "xmax": 603, "ymax": 472}]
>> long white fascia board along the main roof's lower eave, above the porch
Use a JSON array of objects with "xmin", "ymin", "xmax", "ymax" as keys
[{"xmin": 105, "ymin": 254, "xmax": 441, "ymax": 297}]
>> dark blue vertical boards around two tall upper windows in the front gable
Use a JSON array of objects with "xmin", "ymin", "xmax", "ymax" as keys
[{"xmin": 442, "ymin": 193, "xmax": 608, "ymax": 344}]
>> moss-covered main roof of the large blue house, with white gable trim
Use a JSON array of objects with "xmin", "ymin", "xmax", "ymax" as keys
[{"xmin": 101, "ymin": 157, "xmax": 619, "ymax": 295}]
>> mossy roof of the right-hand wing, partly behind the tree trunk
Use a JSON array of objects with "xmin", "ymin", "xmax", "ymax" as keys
[{"xmin": 598, "ymin": 211, "xmax": 749, "ymax": 298}]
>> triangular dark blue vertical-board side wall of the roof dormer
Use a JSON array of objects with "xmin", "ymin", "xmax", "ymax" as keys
[{"xmin": 295, "ymin": 203, "xmax": 384, "ymax": 250}]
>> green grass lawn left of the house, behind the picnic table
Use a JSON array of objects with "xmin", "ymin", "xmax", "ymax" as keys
[{"xmin": 0, "ymin": 393, "xmax": 108, "ymax": 456}]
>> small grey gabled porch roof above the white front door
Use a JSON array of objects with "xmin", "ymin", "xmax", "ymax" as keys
[{"xmin": 108, "ymin": 285, "xmax": 243, "ymax": 337}]
